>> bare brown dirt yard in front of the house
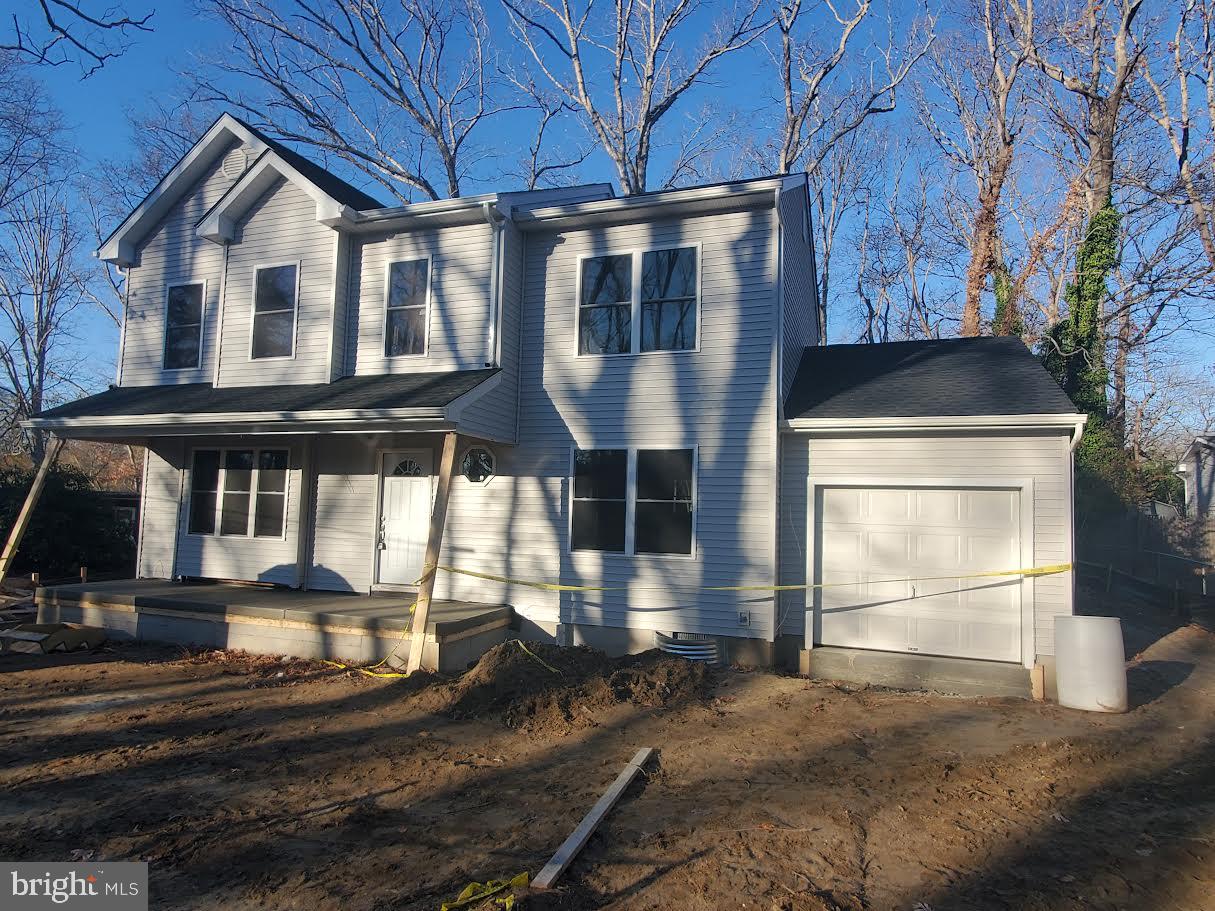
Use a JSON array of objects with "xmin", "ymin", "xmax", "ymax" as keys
[{"xmin": 0, "ymin": 585, "xmax": 1215, "ymax": 911}]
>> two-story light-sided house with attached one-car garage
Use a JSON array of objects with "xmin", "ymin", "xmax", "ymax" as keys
[{"xmin": 34, "ymin": 115, "xmax": 1084, "ymax": 685}]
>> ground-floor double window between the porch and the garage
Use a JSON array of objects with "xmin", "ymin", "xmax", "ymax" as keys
[{"xmin": 570, "ymin": 448, "xmax": 696, "ymax": 554}]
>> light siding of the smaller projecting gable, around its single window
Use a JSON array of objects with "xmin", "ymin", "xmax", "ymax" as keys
[{"xmin": 216, "ymin": 180, "xmax": 337, "ymax": 386}]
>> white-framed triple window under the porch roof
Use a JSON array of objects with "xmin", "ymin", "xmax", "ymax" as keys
[{"xmin": 188, "ymin": 449, "xmax": 288, "ymax": 538}]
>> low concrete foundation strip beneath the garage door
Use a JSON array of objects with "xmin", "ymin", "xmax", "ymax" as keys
[{"xmin": 801, "ymin": 646, "xmax": 1030, "ymax": 698}]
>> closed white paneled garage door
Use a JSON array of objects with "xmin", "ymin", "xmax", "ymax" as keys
[{"xmin": 814, "ymin": 487, "xmax": 1022, "ymax": 662}]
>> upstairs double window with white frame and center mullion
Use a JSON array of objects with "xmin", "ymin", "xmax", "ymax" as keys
[{"xmin": 578, "ymin": 247, "xmax": 700, "ymax": 355}]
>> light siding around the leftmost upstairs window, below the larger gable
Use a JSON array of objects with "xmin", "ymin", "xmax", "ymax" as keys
[{"xmin": 120, "ymin": 137, "xmax": 237, "ymax": 386}]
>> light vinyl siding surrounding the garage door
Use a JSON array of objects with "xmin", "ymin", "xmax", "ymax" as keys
[{"xmin": 780, "ymin": 431, "xmax": 1073, "ymax": 655}]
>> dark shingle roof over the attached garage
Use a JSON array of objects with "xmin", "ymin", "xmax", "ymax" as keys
[{"xmin": 785, "ymin": 338, "xmax": 1076, "ymax": 419}]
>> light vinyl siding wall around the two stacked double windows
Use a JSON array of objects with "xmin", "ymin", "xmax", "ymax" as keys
[{"xmin": 436, "ymin": 210, "xmax": 776, "ymax": 638}]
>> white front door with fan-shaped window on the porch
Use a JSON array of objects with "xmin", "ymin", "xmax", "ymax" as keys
[{"xmin": 375, "ymin": 449, "xmax": 433, "ymax": 585}]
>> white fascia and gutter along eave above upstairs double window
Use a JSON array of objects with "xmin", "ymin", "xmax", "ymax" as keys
[{"xmin": 514, "ymin": 177, "xmax": 784, "ymax": 231}]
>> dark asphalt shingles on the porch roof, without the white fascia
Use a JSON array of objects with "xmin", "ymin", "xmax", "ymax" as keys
[{"xmin": 38, "ymin": 368, "xmax": 498, "ymax": 418}]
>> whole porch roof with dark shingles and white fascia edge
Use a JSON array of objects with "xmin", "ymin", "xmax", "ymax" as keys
[{"xmin": 26, "ymin": 368, "xmax": 499, "ymax": 436}]
